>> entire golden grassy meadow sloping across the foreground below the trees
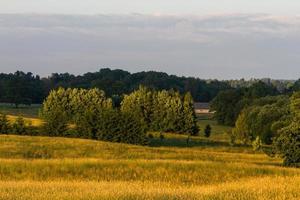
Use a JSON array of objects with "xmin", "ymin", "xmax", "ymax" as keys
[{"xmin": 0, "ymin": 105, "xmax": 300, "ymax": 200}]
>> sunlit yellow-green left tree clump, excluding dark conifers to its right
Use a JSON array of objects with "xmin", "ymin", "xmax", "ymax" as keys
[{"xmin": 41, "ymin": 88, "xmax": 112, "ymax": 139}]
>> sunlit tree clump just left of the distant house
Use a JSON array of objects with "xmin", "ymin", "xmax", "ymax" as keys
[{"xmin": 121, "ymin": 87, "xmax": 198, "ymax": 135}]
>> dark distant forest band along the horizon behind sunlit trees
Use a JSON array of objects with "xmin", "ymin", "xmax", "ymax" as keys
[{"xmin": 0, "ymin": 68, "xmax": 300, "ymax": 106}]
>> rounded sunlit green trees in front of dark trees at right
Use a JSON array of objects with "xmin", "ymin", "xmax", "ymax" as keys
[{"xmin": 232, "ymin": 96, "xmax": 290, "ymax": 144}]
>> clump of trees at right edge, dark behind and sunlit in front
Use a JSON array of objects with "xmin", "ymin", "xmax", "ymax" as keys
[{"xmin": 210, "ymin": 81, "xmax": 300, "ymax": 167}]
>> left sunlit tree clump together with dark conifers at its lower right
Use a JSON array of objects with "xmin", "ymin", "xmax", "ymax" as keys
[{"xmin": 41, "ymin": 88, "xmax": 146, "ymax": 144}]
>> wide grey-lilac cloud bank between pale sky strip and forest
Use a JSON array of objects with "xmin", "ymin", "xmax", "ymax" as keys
[{"xmin": 0, "ymin": 14, "xmax": 300, "ymax": 79}]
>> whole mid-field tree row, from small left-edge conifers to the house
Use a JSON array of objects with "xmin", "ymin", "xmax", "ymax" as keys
[{"xmin": 0, "ymin": 86, "xmax": 198, "ymax": 145}]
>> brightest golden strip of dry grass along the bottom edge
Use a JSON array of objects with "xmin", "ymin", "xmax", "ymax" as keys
[{"xmin": 0, "ymin": 176, "xmax": 300, "ymax": 200}]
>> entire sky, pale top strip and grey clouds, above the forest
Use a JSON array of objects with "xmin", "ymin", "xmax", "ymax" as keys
[{"xmin": 0, "ymin": 0, "xmax": 300, "ymax": 79}]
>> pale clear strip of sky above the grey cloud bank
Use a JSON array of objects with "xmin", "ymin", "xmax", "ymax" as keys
[{"xmin": 0, "ymin": 0, "xmax": 300, "ymax": 15}]
